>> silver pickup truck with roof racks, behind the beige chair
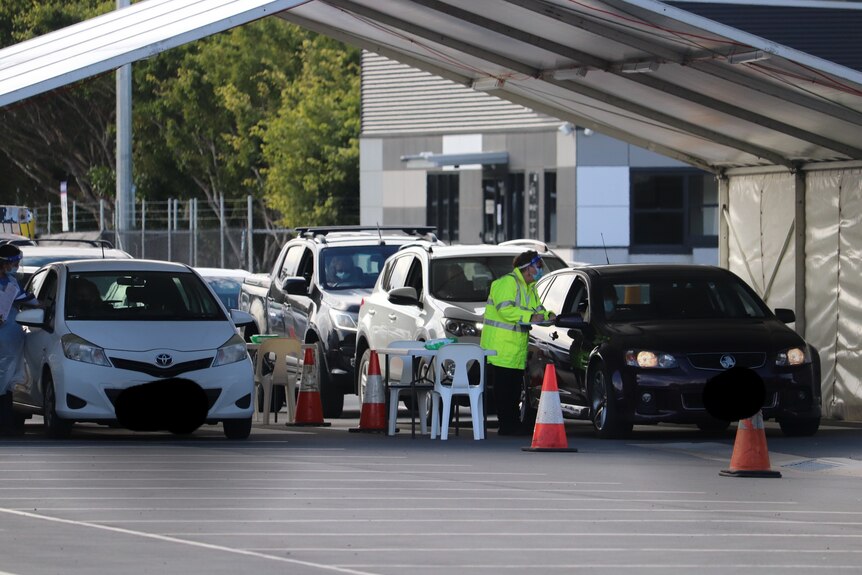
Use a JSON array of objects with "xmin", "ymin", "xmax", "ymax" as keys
[{"xmin": 240, "ymin": 226, "xmax": 440, "ymax": 418}]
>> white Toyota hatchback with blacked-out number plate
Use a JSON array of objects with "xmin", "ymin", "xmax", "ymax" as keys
[{"xmin": 13, "ymin": 259, "xmax": 254, "ymax": 439}]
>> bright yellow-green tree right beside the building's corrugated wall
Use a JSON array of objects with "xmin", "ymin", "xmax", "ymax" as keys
[{"xmin": 262, "ymin": 34, "xmax": 360, "ymax": 226}]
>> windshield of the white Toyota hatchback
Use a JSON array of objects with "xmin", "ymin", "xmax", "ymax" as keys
[{"xmin": 66, "ymin": 271, "xmax": 225, "ymax": 321}]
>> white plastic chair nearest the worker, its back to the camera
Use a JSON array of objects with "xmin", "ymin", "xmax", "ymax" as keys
[{"xmin": 431, "ymin": 343, "xmax": 485, "ymax": 440}]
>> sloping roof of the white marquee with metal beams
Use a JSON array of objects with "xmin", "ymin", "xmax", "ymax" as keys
[{"xmin": 0, "ymin": 0, "xmax": 862, "ymax": 173}]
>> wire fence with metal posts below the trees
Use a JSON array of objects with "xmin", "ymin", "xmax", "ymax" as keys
[{"xmin": 33, "ymin": 197, "xmax": 292, "ymax": 272}]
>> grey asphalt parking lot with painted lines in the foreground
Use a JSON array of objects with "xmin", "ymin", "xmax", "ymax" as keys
[{"xmin": 0, "ymin": 400, "xmax": 862, "ymax": 575}]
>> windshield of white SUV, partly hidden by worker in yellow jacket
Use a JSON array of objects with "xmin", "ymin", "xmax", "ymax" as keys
[{"xmin": 429, "ymin": 255, "xmax": 565, "ymax": 303}]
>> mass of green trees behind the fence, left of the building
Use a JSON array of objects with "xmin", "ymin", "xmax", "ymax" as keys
[{"xmin": 0, "ymin": 0, "xmax": 359, "ymax": 245}]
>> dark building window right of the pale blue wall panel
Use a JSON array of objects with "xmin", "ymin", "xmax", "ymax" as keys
[{"xmin": 631, "ymin": 168, "xmax": 718, "ymax": 253}]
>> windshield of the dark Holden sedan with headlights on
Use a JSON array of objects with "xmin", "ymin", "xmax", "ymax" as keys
[{"xmin": 601, "ymin": 276, "xmax": 769, "ymax": 322}]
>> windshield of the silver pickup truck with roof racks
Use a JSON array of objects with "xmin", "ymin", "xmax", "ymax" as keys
[{"xmin": 320, "ymin": 244, "xmax": 399, "ymax": 290}]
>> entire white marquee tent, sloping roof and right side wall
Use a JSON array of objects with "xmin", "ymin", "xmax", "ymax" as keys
[{"xmin": 0, "ymin": 0, "xmax": 862, "ymax": 420}]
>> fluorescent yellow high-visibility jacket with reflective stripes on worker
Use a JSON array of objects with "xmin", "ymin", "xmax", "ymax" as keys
[{"xmin": 480, "ymin": 269, "xmax": 550, "ymax": 369}]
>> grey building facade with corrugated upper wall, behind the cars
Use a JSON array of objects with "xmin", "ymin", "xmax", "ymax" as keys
[{"xmin": 360, "ymin": 52, "xmax": 718, "ymax": 264}]
